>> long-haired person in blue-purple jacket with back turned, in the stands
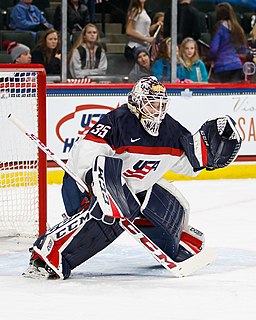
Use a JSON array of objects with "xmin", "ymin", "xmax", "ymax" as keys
[{"xmin": 209, "ymin": 2, "xmax": 246, "ymax": 83}]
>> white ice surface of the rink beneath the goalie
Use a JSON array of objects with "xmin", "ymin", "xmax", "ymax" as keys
[{"xmin": 0, "ymin": 179, "xmax": 256, "ymax": 320}]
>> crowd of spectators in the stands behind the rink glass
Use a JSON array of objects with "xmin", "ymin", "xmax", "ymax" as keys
[{"xmin": 2, "ymin": 0, "xmax": 256, "ymax": 83}]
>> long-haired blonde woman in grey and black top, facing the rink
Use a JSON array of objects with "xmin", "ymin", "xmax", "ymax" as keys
[{"xmin": 68, "ymin": 23, "xmax": 108, "ymax": 78}]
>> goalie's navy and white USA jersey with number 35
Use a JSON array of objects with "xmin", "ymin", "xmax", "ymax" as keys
[{"xmin": 68, "ymin": 104, "xmax": 201, "ymax": 193}]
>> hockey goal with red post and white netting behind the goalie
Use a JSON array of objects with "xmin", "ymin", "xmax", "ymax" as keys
[{"xmin": 0, "ymin": 64, "xmax": 47, "ymax": 237}]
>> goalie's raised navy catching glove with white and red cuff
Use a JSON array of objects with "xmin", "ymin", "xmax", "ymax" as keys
[{"xmin": 183, "ymin": 116, "xmax": 242, "ymax": 171}]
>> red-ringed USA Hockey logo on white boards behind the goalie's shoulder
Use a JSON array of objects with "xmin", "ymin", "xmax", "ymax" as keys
[{"xmin": 55, "ymin": 104, "xmax": 119, "ymax": 153}]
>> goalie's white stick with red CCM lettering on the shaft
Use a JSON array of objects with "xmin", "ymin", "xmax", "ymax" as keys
[{"xmin": 8, "ymin": 114, "xmax": 215, "ymax": 277}]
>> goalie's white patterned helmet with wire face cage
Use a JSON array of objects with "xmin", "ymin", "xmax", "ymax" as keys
[{"xmin": 128, "ymin": 76, "xmax": 168, "ymax": 136}]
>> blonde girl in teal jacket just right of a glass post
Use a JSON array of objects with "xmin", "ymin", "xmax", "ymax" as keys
[{"xmin": 177, "ymin": 37, "xmax": 208, "ymax": 82}]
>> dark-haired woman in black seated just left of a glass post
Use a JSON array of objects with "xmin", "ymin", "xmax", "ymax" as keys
[{"xmin": 32, "ymin": 29, "xmax": 61, "ymax": 75}]
